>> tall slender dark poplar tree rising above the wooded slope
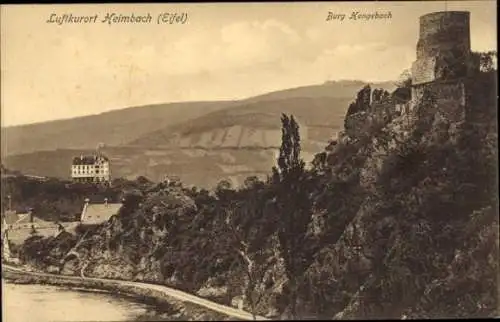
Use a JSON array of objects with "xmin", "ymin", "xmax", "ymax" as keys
[{"xmin": 273, "ymin": 114, "xmax": 312, "ymax": 318}]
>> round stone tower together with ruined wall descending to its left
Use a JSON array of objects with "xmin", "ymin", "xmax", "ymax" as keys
[{"xmin": 344, "ymin": 11, "xmax": 471, "ymax": 138}]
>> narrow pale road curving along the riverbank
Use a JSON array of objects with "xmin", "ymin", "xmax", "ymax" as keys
[{"xmin": 2, "ymin": 264, "xmax": 269, "ymax": 321}]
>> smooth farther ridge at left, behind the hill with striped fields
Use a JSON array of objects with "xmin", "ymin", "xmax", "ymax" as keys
[{"xmin": 1, "ymin": 101, "xmax": 232, "ymax": 157}]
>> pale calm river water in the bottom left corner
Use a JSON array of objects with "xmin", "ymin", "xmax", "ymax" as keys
[{"xmin": 2, "ymin": 279, "xmax": 171, "ymax": 322}]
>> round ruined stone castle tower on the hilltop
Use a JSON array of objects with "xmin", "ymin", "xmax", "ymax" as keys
[{"xmin": 410, "ymin": 11, "xmax": 472, "ymax": 118}]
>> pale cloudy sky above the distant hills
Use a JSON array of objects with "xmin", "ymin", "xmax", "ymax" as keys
[{"xmin": 0, "ymin": 0, "xmax": 497, "ymax": 126}]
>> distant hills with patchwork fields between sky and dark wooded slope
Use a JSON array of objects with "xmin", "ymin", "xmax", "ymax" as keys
[{"xmin": 2, "ymin": 81, "xmax": 395, "ymax": 187}]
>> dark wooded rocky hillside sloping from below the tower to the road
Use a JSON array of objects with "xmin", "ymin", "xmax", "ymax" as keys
[{"xmin": 13, "ymin": 71, "xmax": 499, "ymax": 319}]
